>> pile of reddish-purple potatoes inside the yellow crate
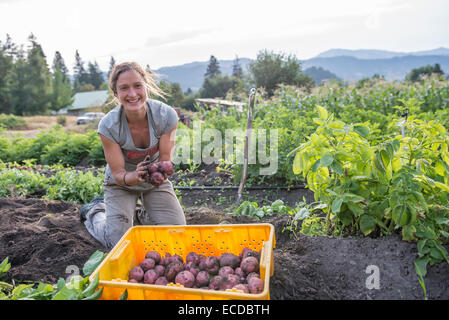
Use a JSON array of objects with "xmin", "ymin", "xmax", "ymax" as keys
[{"xmin": 128, "ymin": 248, "xmax": 264, "ymax": 293}]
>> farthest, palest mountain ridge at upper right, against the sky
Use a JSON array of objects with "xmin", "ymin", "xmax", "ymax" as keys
[{"xmin": 315, "ymin": 47, "xmax": 449, "ymax": 59}]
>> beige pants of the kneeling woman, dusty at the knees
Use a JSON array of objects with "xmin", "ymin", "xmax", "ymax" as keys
[{"xmin": 84, "ymin": 180, "xmax": 186, "ymax": 249}]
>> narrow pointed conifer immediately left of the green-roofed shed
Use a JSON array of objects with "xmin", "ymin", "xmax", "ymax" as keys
[{"xmin": 50, "ymin": 51, "xmax": 73, "ymax": 111}]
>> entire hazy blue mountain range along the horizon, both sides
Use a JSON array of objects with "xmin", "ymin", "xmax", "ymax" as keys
[{"xmin": 155, "ymin": 48, "xmax": 449, "ymax": 91}]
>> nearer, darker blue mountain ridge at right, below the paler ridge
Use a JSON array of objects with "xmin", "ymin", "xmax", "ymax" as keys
[{"xmin": 302, "ymin": 55, "xmax": 449, "ymax": 81}]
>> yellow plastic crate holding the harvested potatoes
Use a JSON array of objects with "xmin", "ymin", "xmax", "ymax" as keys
[{"xmin": 90, "ymin": 223, "xmax": 276, "ymax": 300}]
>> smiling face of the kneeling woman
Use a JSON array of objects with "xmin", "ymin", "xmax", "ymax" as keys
[{"xmin": 115, "ymin": 69, "xmax": 148, "ymax": 111}]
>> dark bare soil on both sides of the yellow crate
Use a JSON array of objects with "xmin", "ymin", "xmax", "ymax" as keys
[{"xmin": 0, "ymin": 198, "xmax": 449, "ymax": 300}]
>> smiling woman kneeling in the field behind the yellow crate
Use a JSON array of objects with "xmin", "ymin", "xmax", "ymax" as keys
[{"xmin": 81, "ymin": 62, "xmax": 186, "ymax": 249}]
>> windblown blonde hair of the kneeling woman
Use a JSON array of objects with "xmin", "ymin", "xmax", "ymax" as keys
[{"xmin": 109, "ymin": 62, "xmax": 166, "ymax": 104}]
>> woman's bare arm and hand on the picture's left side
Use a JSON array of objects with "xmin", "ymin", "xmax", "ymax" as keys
[{"xmin": 100, "ymin": 134, "xmax": 146, "ymax": 186}]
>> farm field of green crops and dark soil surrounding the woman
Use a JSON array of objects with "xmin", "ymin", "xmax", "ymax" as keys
[{"xmin": 0, "ymin": 81, "xmax": 449, "ymax": 300}]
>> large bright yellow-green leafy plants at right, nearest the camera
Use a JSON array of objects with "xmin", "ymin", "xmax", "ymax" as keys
[{"xmin": 292, "ymin": 105, "xmax": 449, "ymax": 284}]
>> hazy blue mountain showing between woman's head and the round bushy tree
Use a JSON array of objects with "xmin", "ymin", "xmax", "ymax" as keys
[{"xmin": 154, "ymin": 58, "xmax": 251, "ymax": 91}]
